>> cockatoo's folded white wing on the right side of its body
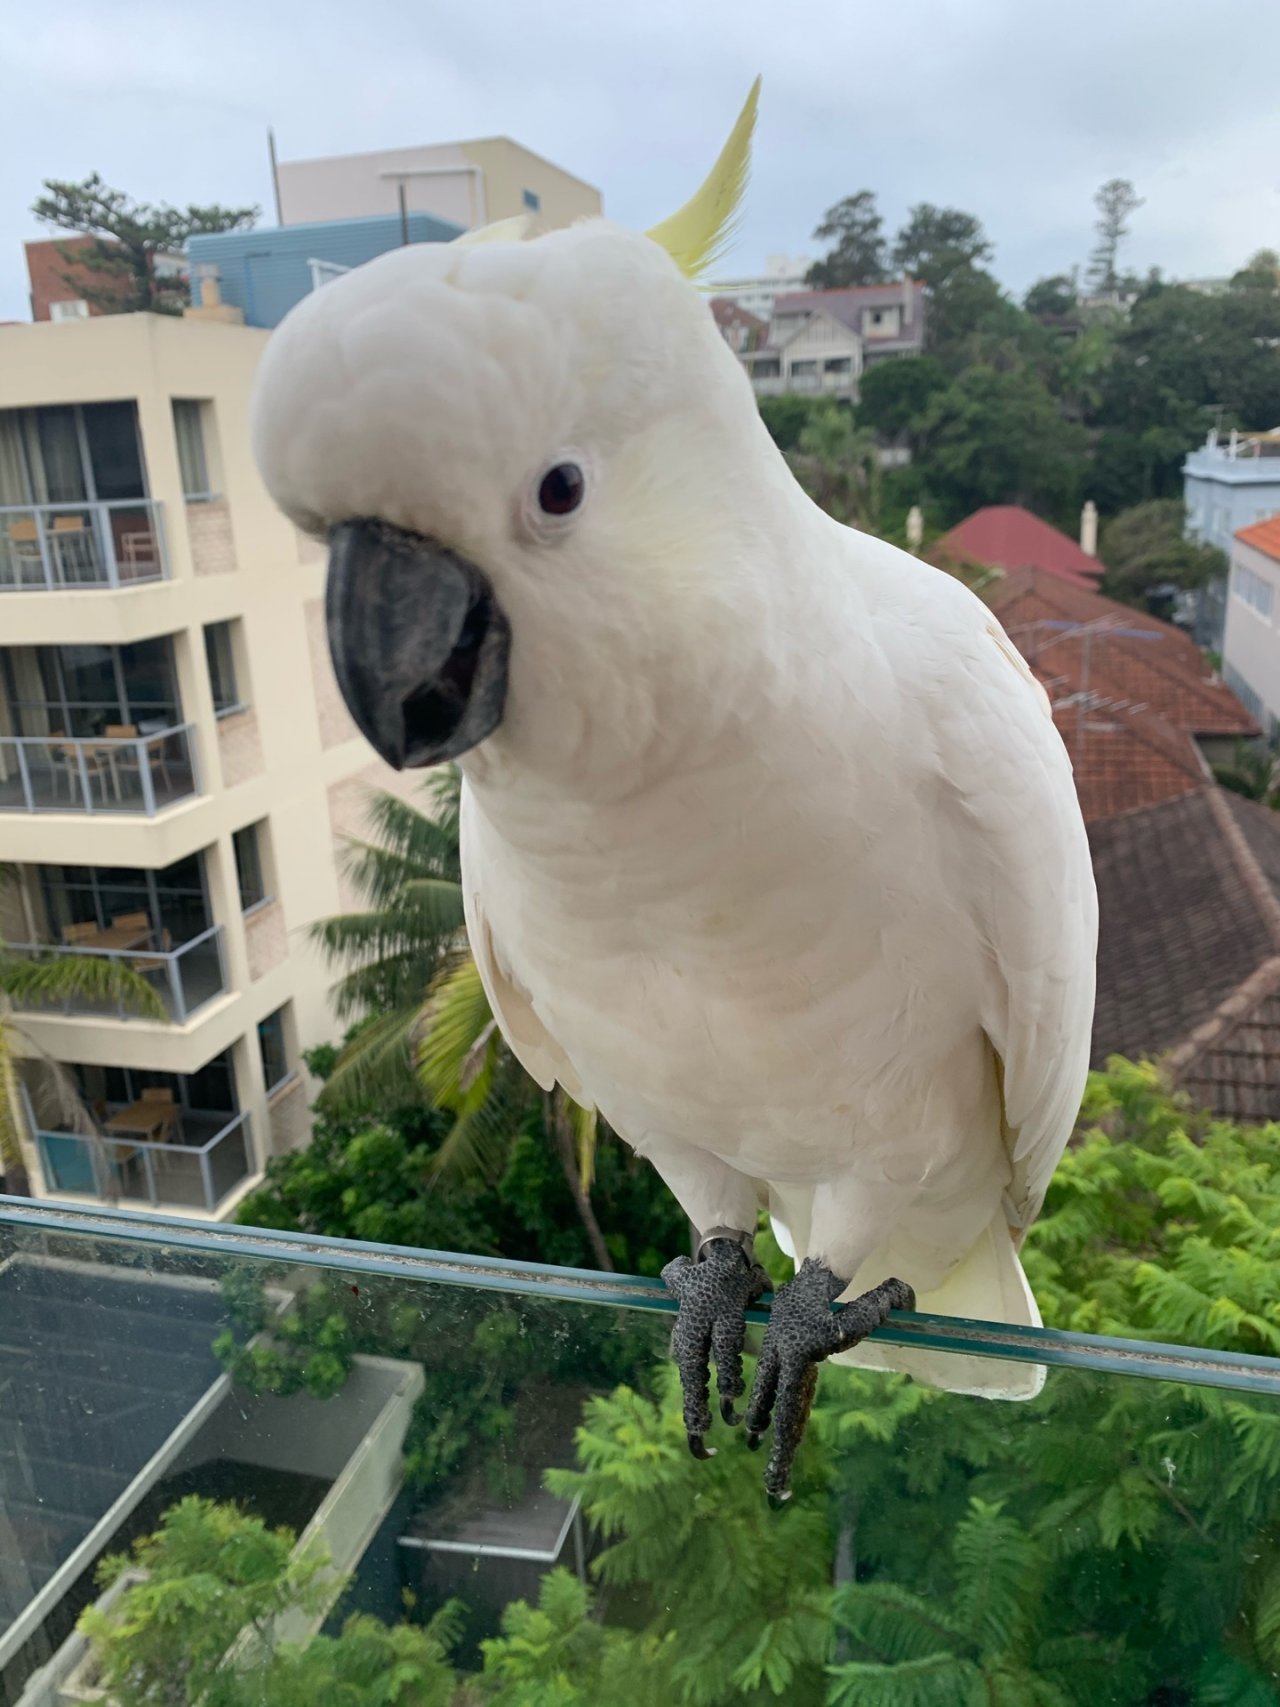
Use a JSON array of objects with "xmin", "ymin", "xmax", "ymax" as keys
[{"xmin": 935, "ymin": 599, "xmax": 1097, "ymax": 1227}]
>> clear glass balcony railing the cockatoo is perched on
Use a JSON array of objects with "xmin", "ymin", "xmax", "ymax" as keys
[{"xmin": 0, "ymin": 1201, "xmax": 1280, "ymax": 1707}]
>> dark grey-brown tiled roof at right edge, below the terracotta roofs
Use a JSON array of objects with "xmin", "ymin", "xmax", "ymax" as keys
[{"xmin": 1089, "ymin": 784, "xmax": 1280, "ymax": 1120}]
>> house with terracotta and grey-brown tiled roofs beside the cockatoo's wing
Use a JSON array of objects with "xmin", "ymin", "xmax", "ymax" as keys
[{"xmin": 988, "ymin": 568, "xmax": 1280, "ymax": 1120}]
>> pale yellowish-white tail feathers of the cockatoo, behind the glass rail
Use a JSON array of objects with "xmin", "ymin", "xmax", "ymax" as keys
[{"xmin": 831, "ymin": 1212, "xmax": 1044, "ymax": 1400}]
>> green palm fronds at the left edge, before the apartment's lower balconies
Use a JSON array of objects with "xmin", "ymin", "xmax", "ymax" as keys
[{"xmin": 0, "ymin": 928, "xmax": 169, "ymax": 1197}]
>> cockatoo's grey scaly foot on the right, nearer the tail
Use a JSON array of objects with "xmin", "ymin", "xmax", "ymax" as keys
[{"xmin": 746, "ymin": 1258, "xmax": 915, "ymax": 1506}]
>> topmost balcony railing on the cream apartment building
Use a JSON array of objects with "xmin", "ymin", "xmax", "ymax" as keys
[{"xmin": 0, "ymin": 498, "xmax": 169, "ymax": 592}]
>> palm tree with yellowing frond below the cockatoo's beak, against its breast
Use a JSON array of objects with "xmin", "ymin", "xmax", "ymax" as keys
[{"xmin": 312, "ymin": 766, "xmax": 613, "ymax": 1270}]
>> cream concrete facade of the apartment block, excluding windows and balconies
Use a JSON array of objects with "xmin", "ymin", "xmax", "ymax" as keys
[{"xmin": 0, "ymin": 314, "xmax": 431, "ymax": 1208}]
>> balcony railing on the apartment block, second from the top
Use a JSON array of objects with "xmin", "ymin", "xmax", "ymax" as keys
[{"xmin": 0, "ymin": 724, "xmax": 200, "ymax": 818}]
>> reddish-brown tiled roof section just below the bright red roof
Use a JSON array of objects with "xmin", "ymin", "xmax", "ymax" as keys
[{"xmin": 986, "ymin": 570, "xmax": 1260, "ymax": 751}]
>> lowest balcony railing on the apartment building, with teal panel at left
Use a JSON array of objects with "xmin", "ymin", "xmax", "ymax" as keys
[{"xmin": 36, "ymin": 1113, "xmax": 253, "ymax": 1214}]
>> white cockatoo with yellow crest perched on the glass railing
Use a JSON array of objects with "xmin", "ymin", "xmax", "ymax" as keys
[{"xmin": 254, "ymin": 90, "xmax": 1096, "ymax": 1499}]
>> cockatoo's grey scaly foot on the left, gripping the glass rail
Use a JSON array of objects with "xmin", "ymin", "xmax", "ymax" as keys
[{"xmin": 662, "ymin": 1229, "xmax": 770, "ymax": 1458}]
